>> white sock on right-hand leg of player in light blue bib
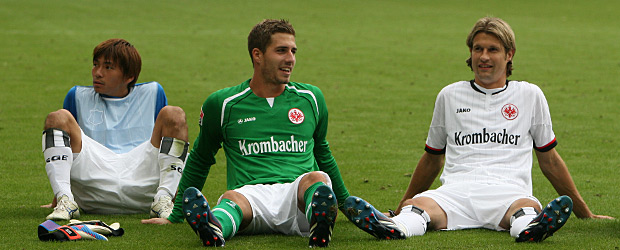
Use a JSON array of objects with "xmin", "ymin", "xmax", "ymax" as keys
[{"xmin": 155, "ymin": 137, "xmax": 189, "ymax": 200}]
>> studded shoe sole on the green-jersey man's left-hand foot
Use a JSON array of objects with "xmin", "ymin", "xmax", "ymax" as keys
[{"xmin": 183, "ymin": 187, "xmax": 225, "ymax": 247}]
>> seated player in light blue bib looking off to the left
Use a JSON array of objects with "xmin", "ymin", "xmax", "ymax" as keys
[{"xmin": 42, "ymin": 39, "xmax": 189, "ymax": 220}]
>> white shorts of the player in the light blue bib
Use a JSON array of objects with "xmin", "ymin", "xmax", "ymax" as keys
[{"xmin": 71, "ymin": 132, "xmax": 160, "ymax": 214}]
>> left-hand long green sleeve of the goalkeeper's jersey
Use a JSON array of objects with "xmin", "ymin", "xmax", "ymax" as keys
[{"xmin": 168, "ymin": 95, "xmax": 222, "ymax": 223}]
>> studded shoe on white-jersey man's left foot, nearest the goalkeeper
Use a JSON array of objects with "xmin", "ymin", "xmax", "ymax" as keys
[{"xmin": 344, "ymin": 196, "xmax": 405, "ymax": 240}]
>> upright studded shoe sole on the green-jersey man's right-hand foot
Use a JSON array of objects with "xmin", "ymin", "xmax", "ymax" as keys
[{"xmin": 308, "ymin": 186, "xmax": 338, "ymax": 247}]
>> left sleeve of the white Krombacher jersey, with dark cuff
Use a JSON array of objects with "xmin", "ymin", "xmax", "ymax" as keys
[{"xmin": 424, "ymin": 89, "xmax": 448, "ymax": 155}]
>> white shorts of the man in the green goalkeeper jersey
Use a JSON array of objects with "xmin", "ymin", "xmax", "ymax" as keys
[{"xmin": 218, "ymin": 171, "xmax": 332, "ymax": 237}]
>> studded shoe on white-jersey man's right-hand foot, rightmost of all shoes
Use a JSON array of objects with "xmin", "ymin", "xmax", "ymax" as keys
[{"xmin": 516, "ymin": 195, "xmax": 573, "ymax": 242}]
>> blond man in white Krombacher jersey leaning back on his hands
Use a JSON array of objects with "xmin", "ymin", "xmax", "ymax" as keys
[{"xmin": 345, "ymin": 17, "xmax": 611, "ymax": 242}]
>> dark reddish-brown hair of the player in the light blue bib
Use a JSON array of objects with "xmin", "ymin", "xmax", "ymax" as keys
[{"xmin": 93, "ymin": 38, "xmax": 142, "ymax": 89}]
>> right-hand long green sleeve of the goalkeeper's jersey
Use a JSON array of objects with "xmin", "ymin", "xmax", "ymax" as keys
[{"xmin": 313, "ymin": 88, "xmax": 349, "ymax": 208}]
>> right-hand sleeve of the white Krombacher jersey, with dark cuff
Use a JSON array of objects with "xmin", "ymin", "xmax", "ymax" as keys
[{"xmin": 530, "ymin": 85, "xmax": 557, "ymax": 152}]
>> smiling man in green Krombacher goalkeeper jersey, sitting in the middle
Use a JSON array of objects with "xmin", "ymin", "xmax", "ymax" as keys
[{"xmin": 143, "ymin": 20, "xmax": 349, "ymax": 247}]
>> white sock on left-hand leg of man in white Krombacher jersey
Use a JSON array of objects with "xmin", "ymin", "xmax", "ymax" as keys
[{"xmin": 392, "ymin": 205, "xmax": 431, "ymax": 237}]
